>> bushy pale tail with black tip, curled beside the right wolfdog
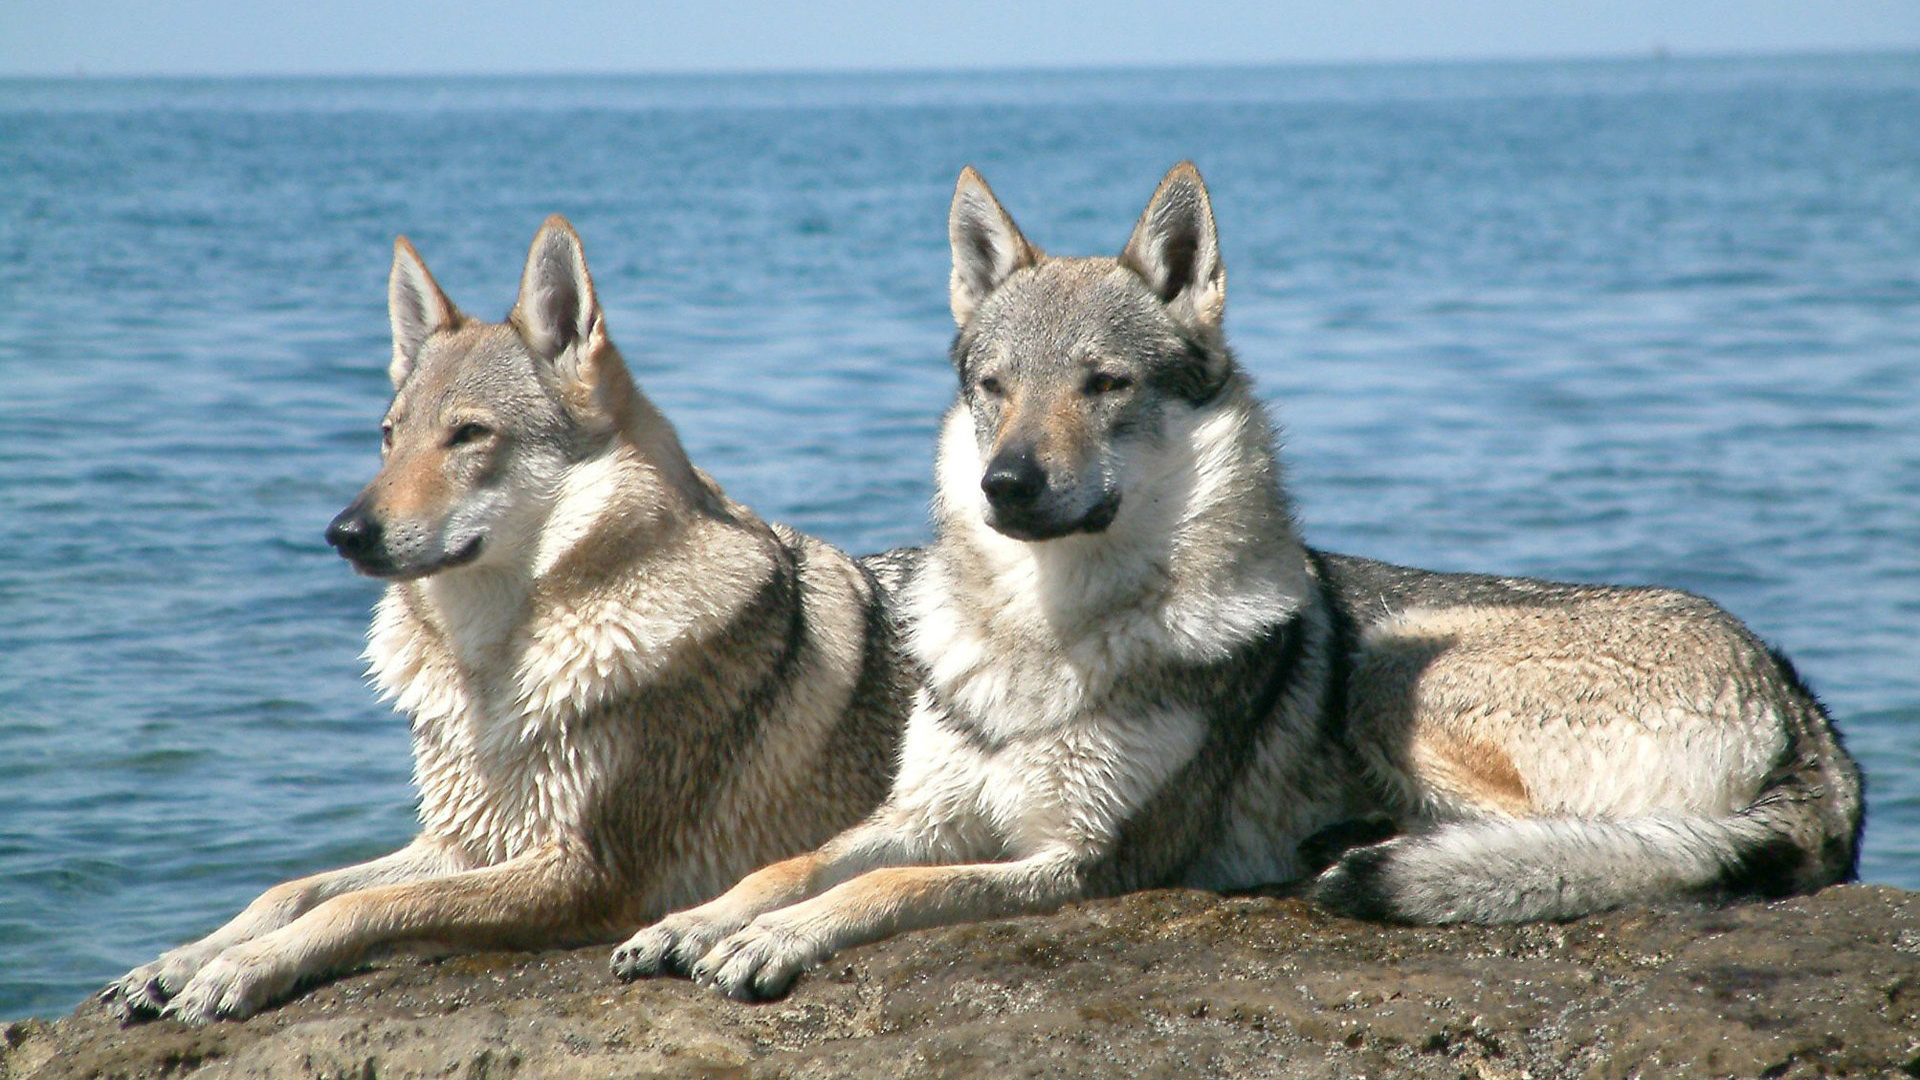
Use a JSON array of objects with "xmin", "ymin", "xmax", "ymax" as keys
[{"xmin": 1311, "ymin": 744, "xmax": 1860, "ymax": 922}]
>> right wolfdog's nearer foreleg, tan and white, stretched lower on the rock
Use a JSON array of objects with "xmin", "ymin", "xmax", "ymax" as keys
[{"xmin": 693, "ymin": 851, "xmax": 1085, "ymax": 1001}]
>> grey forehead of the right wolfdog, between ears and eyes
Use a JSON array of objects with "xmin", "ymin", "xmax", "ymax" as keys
[{"xmin": 964, "ymin": 258, "xmax": 1183, "ymax": 369}]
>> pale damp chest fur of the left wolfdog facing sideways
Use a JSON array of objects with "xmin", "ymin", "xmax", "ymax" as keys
[{"xmin": 367, "ymin": 522, "xmax": 753, "ymax": 863}]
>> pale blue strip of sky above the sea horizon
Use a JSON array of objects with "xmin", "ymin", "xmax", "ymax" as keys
[{"xmin": 0, "ymin": 0, "xmax": 1920, "ymax": 75}]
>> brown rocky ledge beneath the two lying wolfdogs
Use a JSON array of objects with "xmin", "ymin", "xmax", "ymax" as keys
[{"xmin": 0, "ymin": 886, "xmax": 1920, "ymax": 1080}]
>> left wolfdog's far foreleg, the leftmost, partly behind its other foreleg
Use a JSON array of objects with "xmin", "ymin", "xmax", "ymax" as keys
[{"xmin": 100, "ymin": 840, "xmax": 459, "ymax": 1017}]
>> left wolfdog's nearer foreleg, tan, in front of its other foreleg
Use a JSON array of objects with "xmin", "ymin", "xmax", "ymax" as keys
[{"xmin": 161, "ymin": 849, "xmax": 607, "ymax": 1022}]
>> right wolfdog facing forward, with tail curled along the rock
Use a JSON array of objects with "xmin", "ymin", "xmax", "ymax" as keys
[{"xmin": 614, "ymin": 163, "xmax": 1860, "ymax": 999}]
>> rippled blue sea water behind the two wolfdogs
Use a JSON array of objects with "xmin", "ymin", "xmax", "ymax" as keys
[{"xmin": 0, "ymin": 54, "xmax": 1920, "ymax": 1017}]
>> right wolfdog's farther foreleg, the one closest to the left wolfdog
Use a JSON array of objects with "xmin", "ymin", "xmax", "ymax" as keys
[{"xmin": 612, "ymin": 809, "xmax": 941, "ymax": 980}]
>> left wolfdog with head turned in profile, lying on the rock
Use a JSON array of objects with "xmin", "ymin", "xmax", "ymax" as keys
[{"xmin": 104, "ymin": 217, "xmax": 918, "ymax": 1020}]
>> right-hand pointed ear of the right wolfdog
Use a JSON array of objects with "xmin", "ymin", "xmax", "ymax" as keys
[{"xmin": 1119, "ymin": 161, "xmax": 1227, "ymax": 329}]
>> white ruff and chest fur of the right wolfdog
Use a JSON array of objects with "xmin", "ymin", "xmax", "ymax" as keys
[{"xmin": 893, "ymin": 390, "xmax": 1311, "ymax": 857}]
